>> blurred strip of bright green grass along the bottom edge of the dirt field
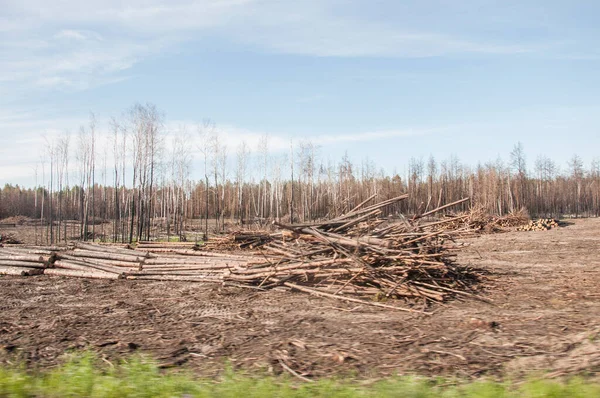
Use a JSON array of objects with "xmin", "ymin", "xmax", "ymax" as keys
[{"xmin": 0, "ymin": 353, "xmax": 600, "ymax": 398}]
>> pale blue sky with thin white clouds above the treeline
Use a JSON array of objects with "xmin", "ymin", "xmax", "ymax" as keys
[{"xmin": 0, "ymin": 0, "xmax": 600, "ymax": 186}]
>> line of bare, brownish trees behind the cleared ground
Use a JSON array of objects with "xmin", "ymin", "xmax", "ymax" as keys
[{"xmin": 0, "ymin": 104, "xmax": 600, "ymax": 243}]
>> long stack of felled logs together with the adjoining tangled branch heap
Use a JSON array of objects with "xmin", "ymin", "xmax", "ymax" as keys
[{"xmin": 0, "ymin": 195, "xmax": 486, "ymax": 311}]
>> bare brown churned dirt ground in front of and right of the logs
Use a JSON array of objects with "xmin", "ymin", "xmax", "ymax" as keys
[{"xmin": 0, "ymin": 219, "xmax": 600, "ymax": 378}]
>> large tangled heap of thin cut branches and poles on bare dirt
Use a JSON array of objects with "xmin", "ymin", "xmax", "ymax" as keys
[{"xmin": 220, "ymin": 195, "xmax": 478, "ymax": 301}]
